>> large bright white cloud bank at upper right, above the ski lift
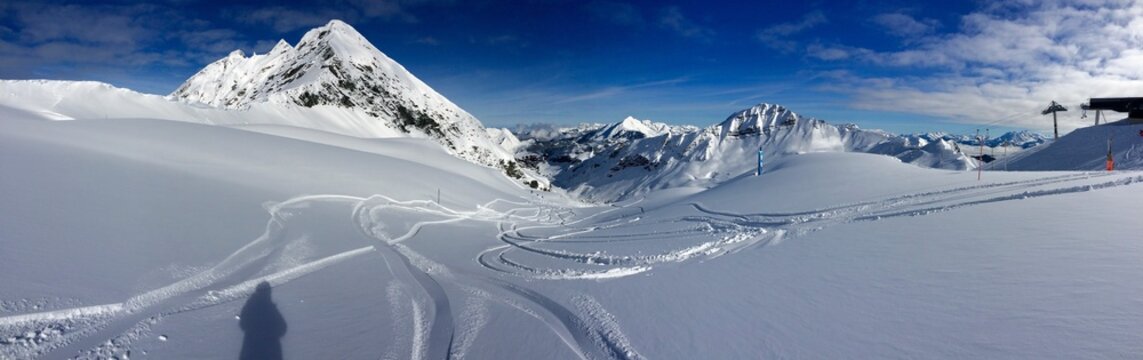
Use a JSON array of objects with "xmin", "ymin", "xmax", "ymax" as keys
[{"xmin": 807, "ymin": 1, "xmax": 1143, "ymax": 129}]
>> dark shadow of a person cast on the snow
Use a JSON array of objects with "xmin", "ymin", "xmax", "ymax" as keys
[{"xmin": 238, "ymin": 281, "xmax": 286, "ymax": 360}]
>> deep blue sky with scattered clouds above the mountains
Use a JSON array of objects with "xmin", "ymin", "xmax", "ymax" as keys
[{"xmin": 0, "ymin": 0, "xmax": 1143, "ymax": 133}]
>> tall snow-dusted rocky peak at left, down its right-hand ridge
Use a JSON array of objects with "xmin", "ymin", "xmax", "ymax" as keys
[{"xmin": 169, "ymin": 19, "xmax": 518, "ymax": 175}]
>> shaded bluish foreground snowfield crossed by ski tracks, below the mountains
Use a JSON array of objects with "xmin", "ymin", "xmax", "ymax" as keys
[{"xmin": 0, "ymin": 111, "xmax": 1143, "ymax": 359}]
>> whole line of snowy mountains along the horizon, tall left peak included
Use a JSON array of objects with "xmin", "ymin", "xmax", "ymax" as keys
[{"xmin": 0, "ymin": 21, "xmax": 1065, "ymax": 201}]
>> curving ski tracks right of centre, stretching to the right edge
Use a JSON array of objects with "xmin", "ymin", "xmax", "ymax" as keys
[{"xmin": 477, "ymin": 173, "xmax": 1143, "ymax": 280}]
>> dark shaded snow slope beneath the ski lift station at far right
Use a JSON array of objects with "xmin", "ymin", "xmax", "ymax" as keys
[{"xmin": 986, "ymin": 119, "xmax": 1143, "ymax": 170}]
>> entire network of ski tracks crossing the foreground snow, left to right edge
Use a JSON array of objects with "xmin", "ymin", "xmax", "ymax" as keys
[{"xmin": 8, "ymin": 173, "xmax": 1129, "ymax": 359}]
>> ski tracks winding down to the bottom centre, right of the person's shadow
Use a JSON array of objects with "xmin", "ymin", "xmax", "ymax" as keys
[{"xmin": 353, "ymin": 195, "xmax": 637, "ymax": 359}]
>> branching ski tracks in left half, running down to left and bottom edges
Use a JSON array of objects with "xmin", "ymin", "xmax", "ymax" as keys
[{"xmin": 0, "ymin": 195, "xmax": 633, "ymax": 359}]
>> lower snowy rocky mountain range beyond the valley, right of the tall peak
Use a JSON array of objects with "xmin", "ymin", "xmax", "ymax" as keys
[{"xmin": 517, "ymin": 104, "xmax": 974, "ymax": 201}]
